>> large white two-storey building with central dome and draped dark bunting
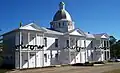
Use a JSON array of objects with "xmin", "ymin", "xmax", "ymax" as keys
[{"xmin": 3, "ymin": 2, "xmax": 110, "ymax": 69}]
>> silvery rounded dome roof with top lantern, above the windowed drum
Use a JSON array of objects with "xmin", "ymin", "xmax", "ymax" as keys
[{"xmin": 53, "ymin": 2, "xmax": 72, "ymax": 21}]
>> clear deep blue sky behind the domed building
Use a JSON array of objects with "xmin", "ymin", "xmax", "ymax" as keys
[{"xmin": 0, "ymin": 0, "xmax": 120, "ymax": 39}]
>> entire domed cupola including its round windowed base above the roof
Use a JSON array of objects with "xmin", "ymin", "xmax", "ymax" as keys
[{"xmin": 50, "ymin": 2, "xmax": 74, "ymax": 32}]
